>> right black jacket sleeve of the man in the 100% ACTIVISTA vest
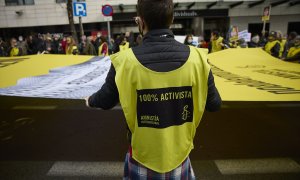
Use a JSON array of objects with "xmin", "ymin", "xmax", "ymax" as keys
[{"xmin": 205, "ymin": 70, "xmax": 222, "ymax": 112}]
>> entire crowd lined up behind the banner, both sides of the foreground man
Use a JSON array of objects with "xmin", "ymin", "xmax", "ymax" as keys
[{"xmin": 0, "ymin": 31, "xmax": 300, "ymax": 61}]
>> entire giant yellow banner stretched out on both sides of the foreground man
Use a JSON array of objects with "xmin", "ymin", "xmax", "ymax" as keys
[{"xmin": 0, "ymin": 48, "xmax": 300, "ymax": 101}]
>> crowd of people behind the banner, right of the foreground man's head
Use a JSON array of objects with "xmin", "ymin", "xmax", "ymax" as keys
[{"xmin": 184, "ymin": 31, "xmax": 300, "ymax": 61}]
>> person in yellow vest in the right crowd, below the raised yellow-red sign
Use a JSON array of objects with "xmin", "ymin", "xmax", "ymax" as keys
[{"xmin": 264, "ymin": 31, "xmax": 280, "ymax": 58}]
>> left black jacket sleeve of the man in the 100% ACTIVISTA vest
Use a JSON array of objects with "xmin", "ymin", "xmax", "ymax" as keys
[{"xmin": 88, "ymin": 65, "xmax": 119, "ymax": 110}]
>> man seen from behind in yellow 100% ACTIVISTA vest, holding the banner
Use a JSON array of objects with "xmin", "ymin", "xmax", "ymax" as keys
[{"xmin": 85, "ymin": 0, "xmax": 221, "ymax": 179}]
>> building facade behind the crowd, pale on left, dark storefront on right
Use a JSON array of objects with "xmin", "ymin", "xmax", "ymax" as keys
[{"xmin": 0, "ymin": 0, "xmax": 300, "ymax": 38}]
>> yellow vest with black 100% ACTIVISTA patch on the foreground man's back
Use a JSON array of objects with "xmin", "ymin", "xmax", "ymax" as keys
[{"xmin": 111, "ymin": 46, "xmax": 210, "ymax": 173}]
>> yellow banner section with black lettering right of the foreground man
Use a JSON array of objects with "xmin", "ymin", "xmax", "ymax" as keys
[{"xmin": 209, "ymin": 48, "xmax": 300, "ymax": 101}]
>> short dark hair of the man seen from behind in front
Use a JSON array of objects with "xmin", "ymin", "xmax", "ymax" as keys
[{"xmin": 137, "ymin": 0, "xmax": 174, "ymax": 30}]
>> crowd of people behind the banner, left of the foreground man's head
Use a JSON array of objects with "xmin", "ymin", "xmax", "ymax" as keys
[{"xmin": 0, "ymin": 32, "xmax": 142, "ymax": 57}]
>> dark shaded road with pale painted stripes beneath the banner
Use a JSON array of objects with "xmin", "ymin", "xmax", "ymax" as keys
[{"xmin": 0, "ymin": 96, "xmax": 300, "ymax": 180}]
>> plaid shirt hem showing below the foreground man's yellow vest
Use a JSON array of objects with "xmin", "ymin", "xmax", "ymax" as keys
[{"xmin": 123, "ymin": 152, "xmax": 196, "ymax": 180}]
